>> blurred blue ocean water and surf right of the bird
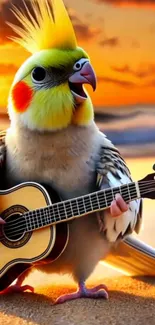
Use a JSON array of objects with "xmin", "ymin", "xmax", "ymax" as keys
[{"xmin": 96, "ymin": 107, "xmax": 155, "ymax": 157}]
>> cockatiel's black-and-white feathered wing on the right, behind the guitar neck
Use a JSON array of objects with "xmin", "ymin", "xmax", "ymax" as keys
[{"xmin": 97, "ymin": 131, "xmax": 142, "ymax": 242}]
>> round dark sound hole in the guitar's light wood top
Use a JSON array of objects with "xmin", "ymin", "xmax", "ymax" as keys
[{"xmin": 3, "ymin": 213, "xmax": 26, "ymax": 241}]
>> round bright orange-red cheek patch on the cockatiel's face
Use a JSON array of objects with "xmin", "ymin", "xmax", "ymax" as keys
[{"xmin": 12, "ymin": 81, "xmax": 33, "ymax": 112}]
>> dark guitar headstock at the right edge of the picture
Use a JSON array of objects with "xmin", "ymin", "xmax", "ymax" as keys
[{"xmin": 138, "ymin": 173, "xmax": 155, "ymax": 200}]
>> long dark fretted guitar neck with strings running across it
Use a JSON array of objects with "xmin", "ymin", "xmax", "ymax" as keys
[{"xmin": 24, "ymin": 182, "xmax": 141, "ymax": 231}]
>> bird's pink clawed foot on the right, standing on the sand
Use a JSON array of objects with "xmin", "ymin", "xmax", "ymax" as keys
[{"xmin": 55, "ymin": 282, "xmax": 108, "ymax": 304}]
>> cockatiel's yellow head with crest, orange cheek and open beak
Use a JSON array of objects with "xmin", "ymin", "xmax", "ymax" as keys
[{"xmin": 8, "ymin": 0, "xmax": 96, "ymax": 131}]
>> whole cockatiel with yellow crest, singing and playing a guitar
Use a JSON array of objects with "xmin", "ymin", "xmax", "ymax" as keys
[{"xmin": 1, "ymin": 0, "xmax": 141, "ymax": 303}]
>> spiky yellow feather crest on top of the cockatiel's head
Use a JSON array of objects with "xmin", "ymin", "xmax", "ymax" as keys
[{"xmin": 8, "ymin": 0, "xmax": 77, "ymax": 53}]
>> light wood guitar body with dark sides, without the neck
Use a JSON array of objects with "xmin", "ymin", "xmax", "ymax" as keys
[{"xmin": 0, "ymin": 182, "xmax": 69, "ymax": 291}]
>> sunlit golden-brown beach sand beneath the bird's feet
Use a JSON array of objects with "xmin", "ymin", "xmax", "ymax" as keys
[{"xmin": 0, "ymin": 276, "xmax": 155, "ymax": 325}]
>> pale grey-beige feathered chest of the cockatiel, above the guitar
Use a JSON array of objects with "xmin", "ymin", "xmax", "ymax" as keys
[{"xmin": 7, "ymin": 126, "xmax": 99, "ymax": 198}]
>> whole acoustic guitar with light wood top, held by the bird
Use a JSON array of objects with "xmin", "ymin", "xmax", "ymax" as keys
[{"xmin": 0, "ymin": 173, "xmax": 155, "ymax": 291}]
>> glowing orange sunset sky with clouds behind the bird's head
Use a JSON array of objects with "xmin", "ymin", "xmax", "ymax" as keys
[{"xmin": 0, "ymin": 0, "xmax": 155, "ymax": 110}]
